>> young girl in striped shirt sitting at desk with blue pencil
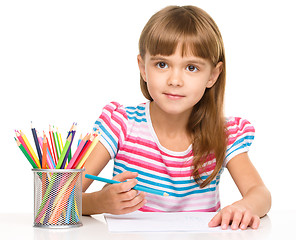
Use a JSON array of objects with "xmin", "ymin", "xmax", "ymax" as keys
[{"xmin": 82, "ymin": 6, "xmax": 271, "ymax": 229}]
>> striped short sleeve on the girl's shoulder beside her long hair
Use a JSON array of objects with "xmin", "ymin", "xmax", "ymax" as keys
[{"xmin": 223, "ymin": 117, "xmax": 255, "ymax": 167}]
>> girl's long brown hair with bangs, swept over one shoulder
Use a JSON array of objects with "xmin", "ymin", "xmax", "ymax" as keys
[{"xmin": 139, "ymin": 6, "xmax": 227, "ymax": 187}]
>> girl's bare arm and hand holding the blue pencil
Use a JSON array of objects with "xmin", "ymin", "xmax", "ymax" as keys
[{"xmin": 82, "ymin": 142, "xmax": 146, "ymax": 215}]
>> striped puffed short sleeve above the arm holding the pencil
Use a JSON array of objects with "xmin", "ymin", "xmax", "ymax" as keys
[{"xmin": 93, "ymin": 102, "xmax": 127, "ymax": 158}]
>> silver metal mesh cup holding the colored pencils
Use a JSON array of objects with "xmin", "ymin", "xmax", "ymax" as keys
[{"xmin": 33, "ymin": 169, "xmax": 84, "ymax": 228}]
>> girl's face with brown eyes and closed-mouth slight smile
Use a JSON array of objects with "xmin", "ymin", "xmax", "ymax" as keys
[{"xmin": 138, "ymin": 45, "xmax": 223, "ymax": 118}]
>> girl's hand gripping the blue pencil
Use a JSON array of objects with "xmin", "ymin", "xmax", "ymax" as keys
[{"xmin": 96, "ymin": 171, "xmax": 147, "ymax": 215}]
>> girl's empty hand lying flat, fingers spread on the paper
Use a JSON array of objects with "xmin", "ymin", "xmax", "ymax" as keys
[{"xmin": 209, "ymin": 201, "xmax": 260, "ymax": 230}]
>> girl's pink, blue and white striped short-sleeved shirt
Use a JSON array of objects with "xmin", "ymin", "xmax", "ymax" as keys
[{"xmin": 94, "ymin": 102, "xmax": 255, "ymax": 212}]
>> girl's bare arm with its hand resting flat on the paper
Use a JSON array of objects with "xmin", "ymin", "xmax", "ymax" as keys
[{"xmin": 209, "ymin": 153, "xmax": 271, "ymax": 230}]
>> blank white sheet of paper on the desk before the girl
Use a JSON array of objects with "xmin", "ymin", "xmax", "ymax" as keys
[{"xmin": 105, "ymin": 211, "xmax": 235, "ymax": 232}]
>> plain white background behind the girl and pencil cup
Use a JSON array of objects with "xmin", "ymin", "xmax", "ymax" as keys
[{"xmin": 0, "ymin": 0, "xmax": 296, "ymax": 213}]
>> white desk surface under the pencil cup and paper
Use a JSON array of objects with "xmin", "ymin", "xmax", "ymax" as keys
[{"xmin": 0, "ymin": 211, "xmax": 296, "ymax": 240}]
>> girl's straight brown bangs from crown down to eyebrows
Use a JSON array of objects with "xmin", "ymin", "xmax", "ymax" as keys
[{"xmin": 139, "ymin": 7, "xmax": 223, "ymax": 65}]
